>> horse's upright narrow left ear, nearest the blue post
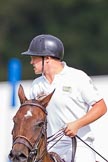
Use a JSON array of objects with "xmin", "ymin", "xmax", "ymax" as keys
[{"xmin": 18, "ymin": 84, "xmax": 27, "ymax": 104}]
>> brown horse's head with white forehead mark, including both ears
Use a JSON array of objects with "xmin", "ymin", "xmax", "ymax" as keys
[{"xmin": 9, "ymin": 85, "xmax": 53, "ymax": 162}]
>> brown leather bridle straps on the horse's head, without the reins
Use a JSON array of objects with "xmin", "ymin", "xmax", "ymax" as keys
[{"xmin": 12, "ymin": 100, "xmax": 47, "ymax": 162}]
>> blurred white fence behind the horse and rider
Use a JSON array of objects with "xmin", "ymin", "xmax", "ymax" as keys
[{"xmin": 0, "ymin": 76, "xmax": 108, "ymax": 162}]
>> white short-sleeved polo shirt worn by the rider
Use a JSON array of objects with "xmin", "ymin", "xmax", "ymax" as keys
[{"xmin": 30, "ymin": 62, "xmax": 102, "ymax": 159}]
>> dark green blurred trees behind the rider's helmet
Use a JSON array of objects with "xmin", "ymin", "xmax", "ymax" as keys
[{"xmin": 0, "ymin": 0, "xmax": 108, "ymax": 81}]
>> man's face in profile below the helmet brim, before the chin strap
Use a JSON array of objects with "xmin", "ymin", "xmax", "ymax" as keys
[{"xmin": 30, "ymin": 56, "xmax": 42, "ymax": 74}]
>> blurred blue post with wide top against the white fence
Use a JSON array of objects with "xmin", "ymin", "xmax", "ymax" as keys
[{"xmin": 8, "ymin": 58, "xmax": 22, "ymax": 107}]
